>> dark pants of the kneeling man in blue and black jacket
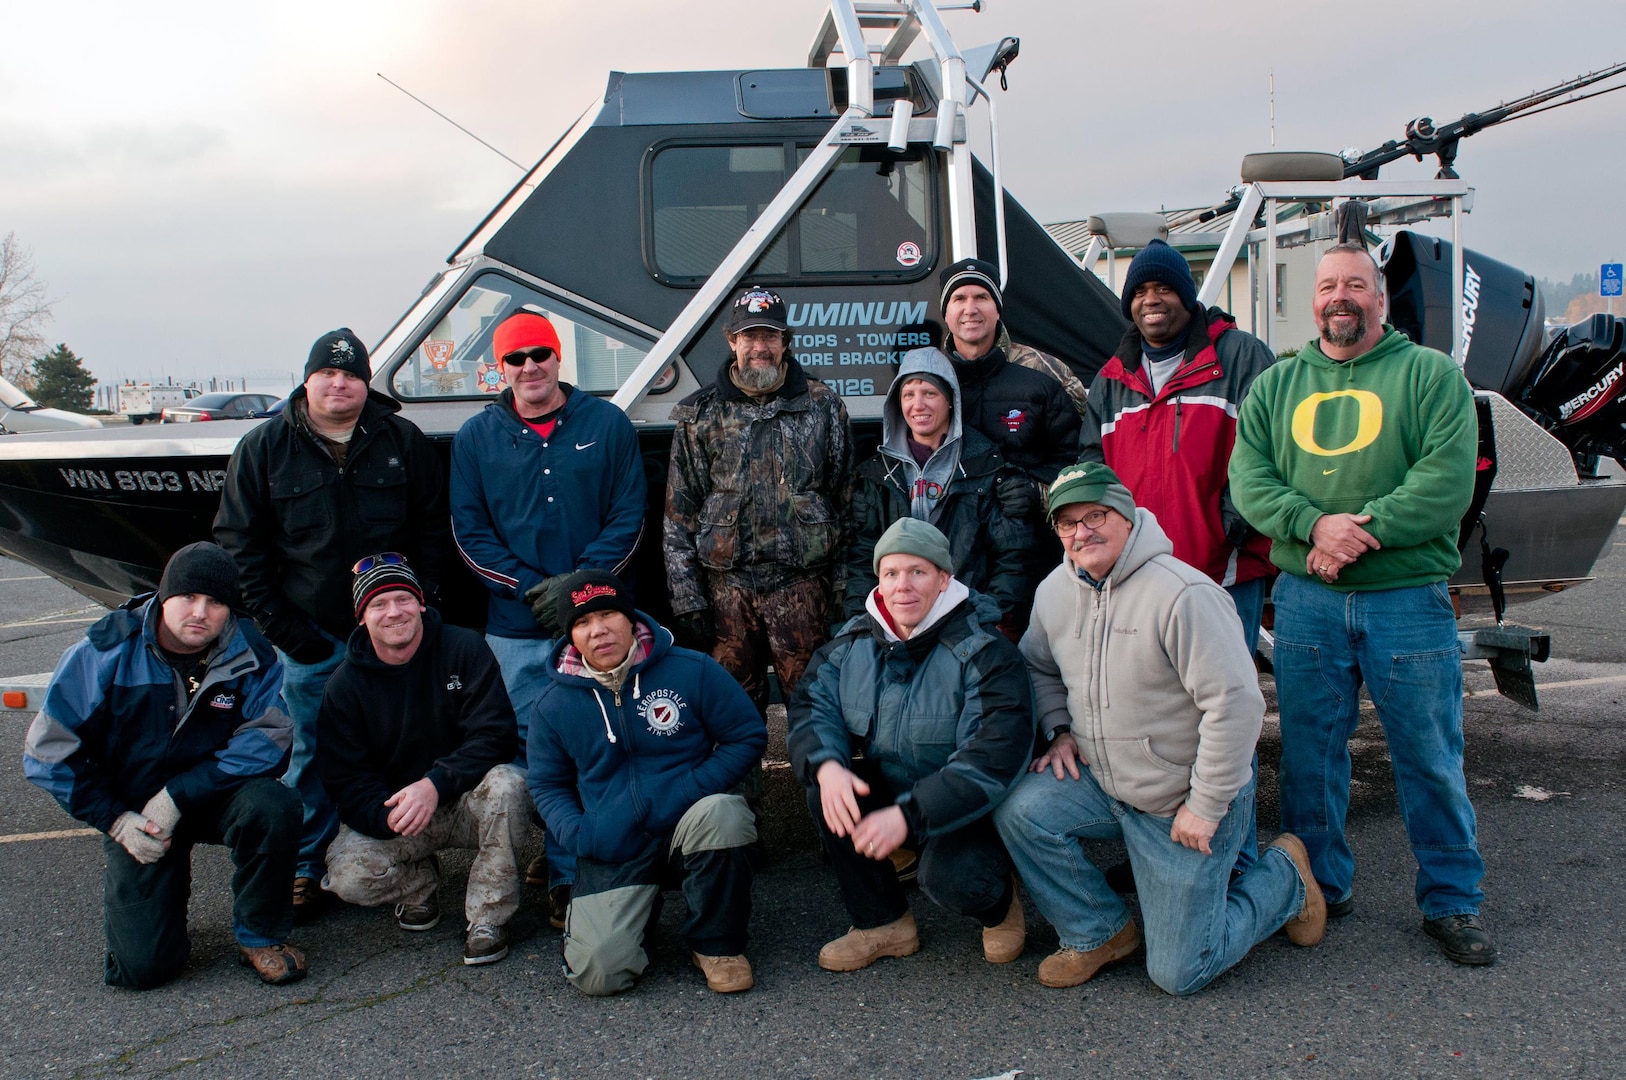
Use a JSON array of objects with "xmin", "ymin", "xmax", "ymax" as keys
[{"xmin": 102, "ymin": 777, "xmax": 299, "ymax": 991}]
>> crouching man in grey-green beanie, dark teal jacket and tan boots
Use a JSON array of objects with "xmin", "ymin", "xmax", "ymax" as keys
[{"xmin": 789, "ymin": 517, "xmax": 1034, "ymax": 971}]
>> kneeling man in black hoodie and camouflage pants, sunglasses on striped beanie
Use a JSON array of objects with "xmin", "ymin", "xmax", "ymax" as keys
[{"xmin": 317, "ymin": 551, "xmax": 532, "ymax": 965}]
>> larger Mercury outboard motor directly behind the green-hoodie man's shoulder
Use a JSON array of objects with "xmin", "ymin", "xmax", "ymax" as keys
[{"xmin": 1377, "ymin": 229, "xmax": 1545, "ymax": 402}]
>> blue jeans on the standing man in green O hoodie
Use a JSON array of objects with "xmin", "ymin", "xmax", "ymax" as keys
[{"xmin": 1273, "ymin": 574, "xmax": 1485, "ymax": 919}]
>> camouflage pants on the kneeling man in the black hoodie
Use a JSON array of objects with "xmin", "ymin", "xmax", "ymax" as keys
[{"xmin": 322, "ymin": 764, "xmax": 532, "ymax": 925}]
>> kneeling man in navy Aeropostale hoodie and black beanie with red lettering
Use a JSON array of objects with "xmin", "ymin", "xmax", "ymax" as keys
[{"xmin": 525, "ymin": 569, "xmax": 767, "ymax": 995}]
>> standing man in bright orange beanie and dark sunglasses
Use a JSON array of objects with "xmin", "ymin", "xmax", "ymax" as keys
[{"xmin": 452, "ymin": 309, "xmax": 647, "ymax": 929}]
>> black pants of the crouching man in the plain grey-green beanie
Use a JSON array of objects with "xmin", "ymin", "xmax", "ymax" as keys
[{"xmin": 808, "ymin": 761, "xmax": 1013, "ymax": 930}]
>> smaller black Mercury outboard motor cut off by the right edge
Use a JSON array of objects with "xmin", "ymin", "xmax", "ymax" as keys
[{"xmin": 1520, "ymin": 312, "xmax": 1626, "ymax": 473}]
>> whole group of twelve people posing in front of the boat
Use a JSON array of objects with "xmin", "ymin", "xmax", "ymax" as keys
[{"xmin": 24, "ymin": 241, "xmax": 1496, "ymax": 994}]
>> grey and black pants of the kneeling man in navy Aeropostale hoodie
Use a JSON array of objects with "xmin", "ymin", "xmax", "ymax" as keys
[{"xmin": 564, "ymin": 795, "xmax": 759, "ymax": 997}]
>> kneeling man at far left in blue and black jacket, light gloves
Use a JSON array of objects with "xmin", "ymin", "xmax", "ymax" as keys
[{"xmin": 23, "ymin": 543, "xmax": 306, "ymax": 991}]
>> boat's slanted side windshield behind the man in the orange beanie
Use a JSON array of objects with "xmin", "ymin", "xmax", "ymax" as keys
[{"xmin": 390, "ymin": 272, "xmax": 675, "ymax": 400}]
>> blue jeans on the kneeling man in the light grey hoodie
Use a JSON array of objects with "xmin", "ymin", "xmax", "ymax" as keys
[{"xmin": 993, "ymin": 769, "xmax": 1304, "ymax": 994}]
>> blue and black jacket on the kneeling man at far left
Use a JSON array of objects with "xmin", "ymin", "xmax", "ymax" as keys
[{"xmin": 23, "ymin": 595, "xmax": 293, "ymax": 833}]
